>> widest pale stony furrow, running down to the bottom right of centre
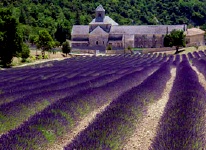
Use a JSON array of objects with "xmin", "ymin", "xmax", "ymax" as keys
[{"xmin": 123, "ymin": 68, "xmax": 176, "ymax": 150}]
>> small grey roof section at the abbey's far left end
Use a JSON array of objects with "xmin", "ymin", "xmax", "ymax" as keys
[{"xmin": 71, "ymin": 25, "xmax": 89, "ymax": 35}]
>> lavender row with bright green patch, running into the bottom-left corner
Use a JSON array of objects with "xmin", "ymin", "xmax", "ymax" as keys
[{"xmin": 0, "ymin": 66, "xmax": 157, "ymax": 149}]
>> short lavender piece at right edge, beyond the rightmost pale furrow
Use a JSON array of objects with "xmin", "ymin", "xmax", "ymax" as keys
[{"xmin": 192, "ymin": 59, "xmax": 206, "ymax": 79}]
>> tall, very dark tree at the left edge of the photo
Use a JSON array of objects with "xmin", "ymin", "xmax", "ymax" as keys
[{"xmin": 0, "ymin": 8, "xmax": 23, "ymax": 67}]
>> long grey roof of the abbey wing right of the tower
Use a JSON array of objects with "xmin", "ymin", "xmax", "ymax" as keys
[{"xmin": 110, "ymin": 25, "xmax": 184, "ymax": 34}]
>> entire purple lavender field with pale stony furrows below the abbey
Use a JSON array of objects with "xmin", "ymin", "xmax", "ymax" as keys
[{"xmin": 0, "ymin": 51, "xmax": 206, "ymax": 150}]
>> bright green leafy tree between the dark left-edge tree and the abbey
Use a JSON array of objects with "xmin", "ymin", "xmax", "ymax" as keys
[{"xmin": 35, "ymin": 30, "xmax": 55, "ymax": 58}]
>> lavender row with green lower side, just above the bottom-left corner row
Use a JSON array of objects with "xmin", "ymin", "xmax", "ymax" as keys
[{"xmin": 0, "ymin": 69, "xmax": 133, "ymax": 134}]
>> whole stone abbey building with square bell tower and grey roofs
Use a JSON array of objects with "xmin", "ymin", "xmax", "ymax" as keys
[{"xmin": 71, "ymin": 5, "xmax": 204, "ymax": 50}]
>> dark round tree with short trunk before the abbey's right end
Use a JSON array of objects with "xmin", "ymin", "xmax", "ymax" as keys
[{"xmin": 164, "ymin": 30, "xmax": 186, "ymax": 54}]
